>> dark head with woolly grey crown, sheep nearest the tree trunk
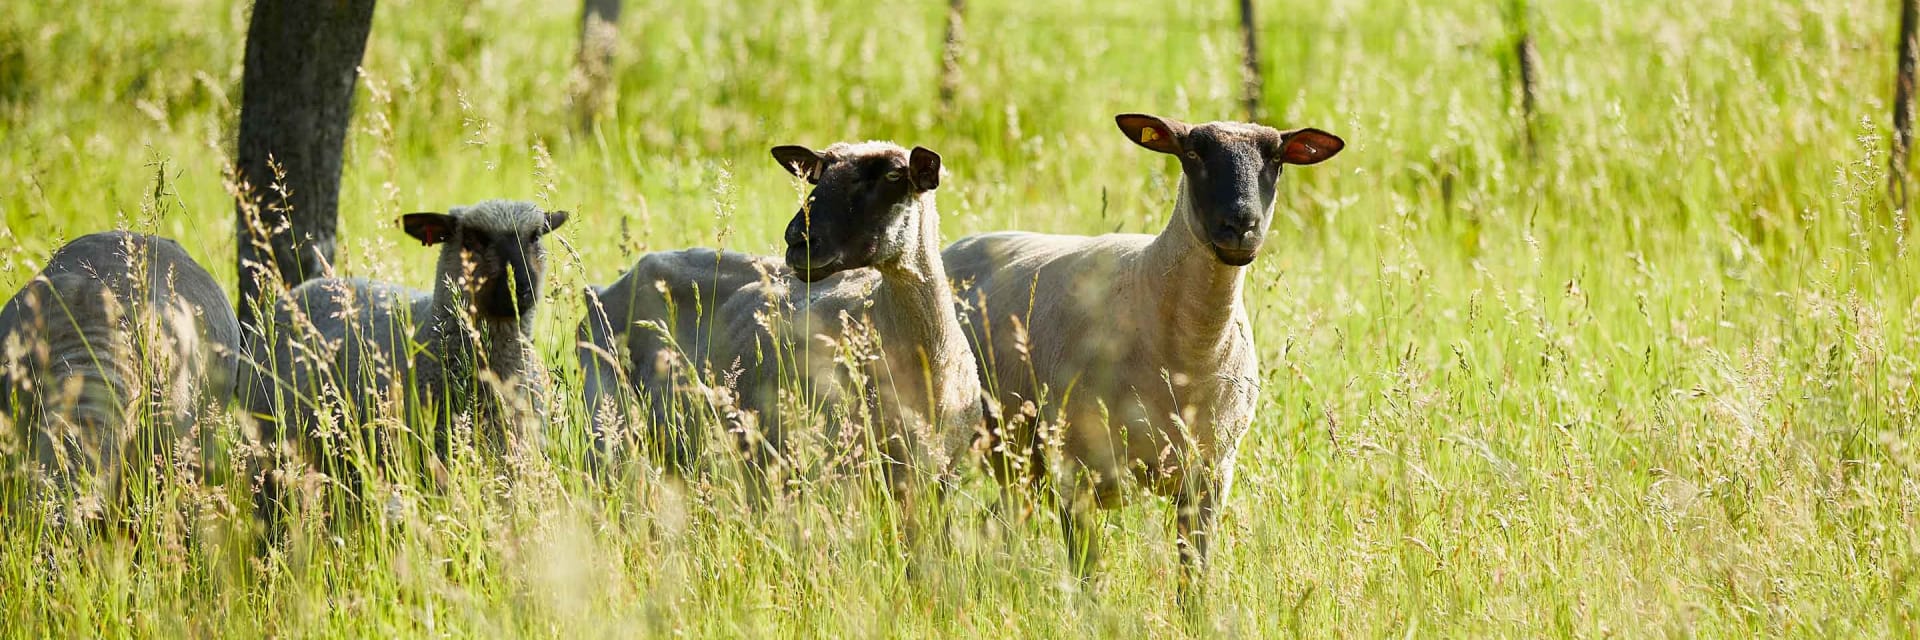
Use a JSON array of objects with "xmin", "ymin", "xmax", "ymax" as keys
[{"xmin": 399, "ymin": 200, "xmax": 566, "ymax": 319}]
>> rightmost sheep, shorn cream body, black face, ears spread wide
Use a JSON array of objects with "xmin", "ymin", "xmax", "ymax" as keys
[{"xmin": 945, "ymin": 113, "xmax": 1344, "ymax": 600}]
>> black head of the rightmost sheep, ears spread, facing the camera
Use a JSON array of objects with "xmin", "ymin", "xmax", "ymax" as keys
[{"xmin": 1114, "ymin": 113, "xmax": 1346, "ymax": 267}]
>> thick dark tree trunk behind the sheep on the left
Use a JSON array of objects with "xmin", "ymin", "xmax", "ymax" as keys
[{"xmin": 234, "ymin": 0, "xmax": 374, "ymax": 332}]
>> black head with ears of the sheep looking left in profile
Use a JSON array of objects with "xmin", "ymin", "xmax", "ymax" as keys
[{"xmin": 774, "ymin": 142, "xmax": 941, "ymax": 283}]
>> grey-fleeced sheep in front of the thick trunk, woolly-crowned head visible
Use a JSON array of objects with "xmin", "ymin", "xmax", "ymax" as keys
[{"xmin": 242, "ymin": 200, "xmax": 568, "ymax": 534}]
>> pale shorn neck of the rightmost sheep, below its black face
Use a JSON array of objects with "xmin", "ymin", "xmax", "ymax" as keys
[{"xmin": 1135, "ymin": 175, "xmax": 1246, "ymax": 354}]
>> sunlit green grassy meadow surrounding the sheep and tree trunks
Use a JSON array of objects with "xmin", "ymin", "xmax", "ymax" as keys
[{"xmin": 0, "ymin": 0, "xmax": 1920, "ymax": 638}]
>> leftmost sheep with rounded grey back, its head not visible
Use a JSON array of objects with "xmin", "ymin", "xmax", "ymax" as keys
[{"xmin": 0, "ymin": 231, "xmax": 240, "ymax": 523}]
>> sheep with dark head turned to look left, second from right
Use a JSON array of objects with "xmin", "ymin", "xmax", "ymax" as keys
[{"xmin": 578, "ymin": 142, "xmax": 981, "ymax": 522}]
